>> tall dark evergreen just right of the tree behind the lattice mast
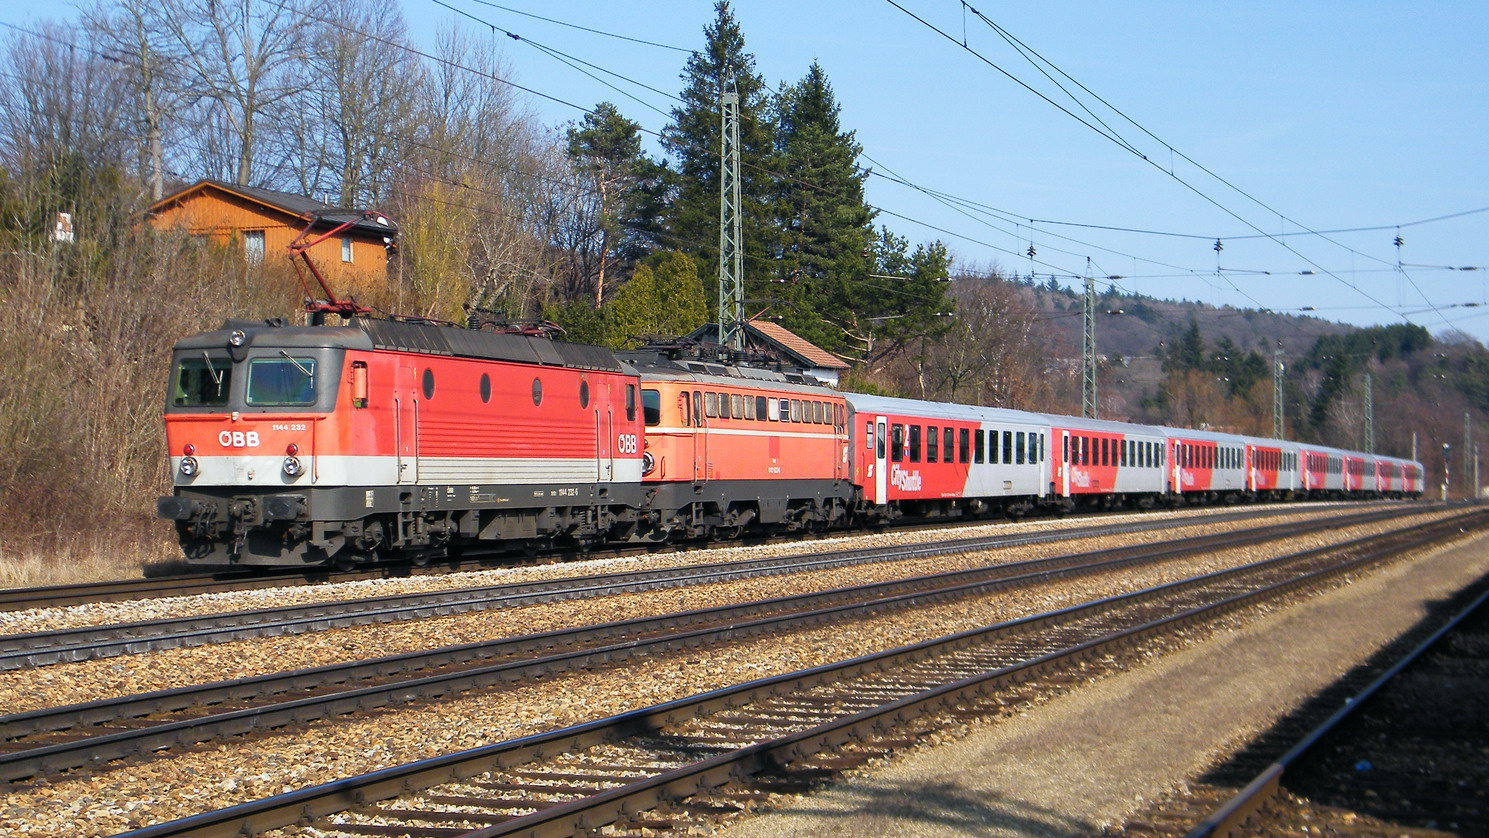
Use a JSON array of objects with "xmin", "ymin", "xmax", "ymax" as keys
[{"xmin": 776, "ymin": 63, "xmax": 874, "ymax": 350}]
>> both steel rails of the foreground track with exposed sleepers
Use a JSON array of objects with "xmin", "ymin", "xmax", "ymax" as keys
[{"xmin": 122, "ymin": 512, "xmax": 1483, "ymax": 838}]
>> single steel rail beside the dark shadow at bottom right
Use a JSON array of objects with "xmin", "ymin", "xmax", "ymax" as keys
[{"xmin": 1185, "ymin": 580, "xmax": 1489, "ymax": 838}]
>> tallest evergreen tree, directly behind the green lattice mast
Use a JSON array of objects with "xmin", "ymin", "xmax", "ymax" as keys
[{"xmin": 661, "ymin": 0, "xmax": 777, "ymax": 308}]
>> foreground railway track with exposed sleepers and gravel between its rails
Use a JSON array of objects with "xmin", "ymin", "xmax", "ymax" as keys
[{"xmin": 110, "ymin": 511, "xmax": 1485, "ymax": 838}]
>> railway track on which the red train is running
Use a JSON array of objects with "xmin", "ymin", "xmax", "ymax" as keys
[{"xmin": 0, "ymin": 505, "xmax": 1393, "ymax": 612}]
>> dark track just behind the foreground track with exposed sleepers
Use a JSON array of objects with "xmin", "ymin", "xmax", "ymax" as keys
[{"xmin": 0, "ymin": 512, "xmax": 1405, "ymax": 781}]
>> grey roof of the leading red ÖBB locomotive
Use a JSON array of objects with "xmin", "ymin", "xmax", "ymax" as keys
[{"xmin": 176, "ymin": 317, "xmax": 628, "ymax": 372}]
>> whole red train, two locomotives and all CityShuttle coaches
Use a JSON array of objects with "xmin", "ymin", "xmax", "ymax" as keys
[{"xmin": 156, "ymin": 317, "xmax": 1423, "ymax": 566}]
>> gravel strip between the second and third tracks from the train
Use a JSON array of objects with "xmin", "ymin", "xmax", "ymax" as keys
[{"xmin": 0, "ymin": 506, "xmax": 1418, "ymax": 713}]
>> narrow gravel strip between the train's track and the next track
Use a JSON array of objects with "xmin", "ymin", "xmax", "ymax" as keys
[{"xmin": 0, "ymin": 503, "xmax": 1361, "ymax": 634}]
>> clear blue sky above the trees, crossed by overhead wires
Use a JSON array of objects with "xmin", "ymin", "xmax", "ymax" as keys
[{"xmin": 0, "ymin": 0, "xmax": 1489, "ymax": 343}]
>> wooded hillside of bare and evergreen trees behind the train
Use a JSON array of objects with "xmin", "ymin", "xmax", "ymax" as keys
[{"xmin": 0, "ymin": 0, "xmax": 1489, "ymax": 574}]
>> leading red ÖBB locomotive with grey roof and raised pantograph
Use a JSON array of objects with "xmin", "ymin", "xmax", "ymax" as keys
[{"xmin": 156, "ymin": 319, "xmax": 642, "ymax": 564}]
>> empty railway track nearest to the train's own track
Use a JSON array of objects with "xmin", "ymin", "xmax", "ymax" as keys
[{"xmin": 0, "ymin": 505, "xmax": 1405, "ymax": 670}]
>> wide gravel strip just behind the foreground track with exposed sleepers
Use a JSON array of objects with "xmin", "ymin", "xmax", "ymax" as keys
[{"xmin": 0, "ymin": 509, "xmax": 1447, "ymax": 837}]
